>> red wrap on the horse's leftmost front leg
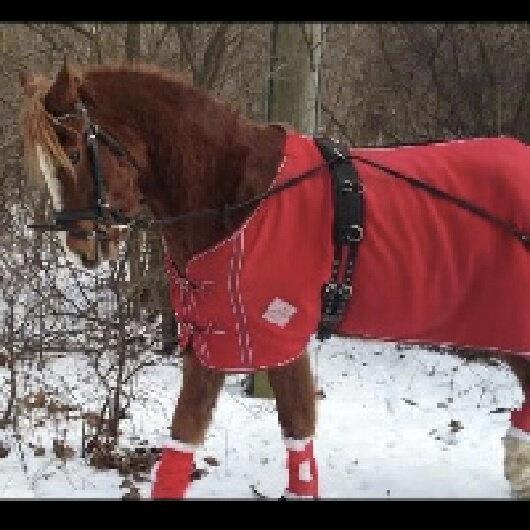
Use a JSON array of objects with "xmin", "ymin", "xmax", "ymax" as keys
[{"xmin": 151, "ymin": 447, "xmax": 193, "ymax": 499}]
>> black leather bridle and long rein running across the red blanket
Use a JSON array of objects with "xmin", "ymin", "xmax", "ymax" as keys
[{"xmin": 28, "ymin": 103, "xmax": 530, "ymax": 250}]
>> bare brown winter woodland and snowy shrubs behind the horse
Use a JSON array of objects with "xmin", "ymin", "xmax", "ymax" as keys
[{"xmin": 0, "ymin": 22, "xmax": 530, "ymax": 478}]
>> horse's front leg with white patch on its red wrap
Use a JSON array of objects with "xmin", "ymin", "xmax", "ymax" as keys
[{"xmin": 269, "ymin": 352, "xmax": 318, "ymax": 497}]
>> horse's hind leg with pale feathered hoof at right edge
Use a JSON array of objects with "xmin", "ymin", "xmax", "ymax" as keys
[{"xmin": 504, "ymin": 357, "xmax": 530, "ymax": 498}]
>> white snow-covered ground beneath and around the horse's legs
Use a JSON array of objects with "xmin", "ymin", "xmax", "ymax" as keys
[{"xmin": 0, "ymin": 339, "xmax": 522, "ymax": 498}]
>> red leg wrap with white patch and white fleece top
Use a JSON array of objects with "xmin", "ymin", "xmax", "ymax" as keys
[{"xmin": 285, "ymin": 438, "xmax": 318, "ymax": 499}]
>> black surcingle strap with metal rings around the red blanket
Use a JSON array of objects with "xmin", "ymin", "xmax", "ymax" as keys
[{"xmin": 314, "ymin": 137, "xmax": 364, "ymax": 341}]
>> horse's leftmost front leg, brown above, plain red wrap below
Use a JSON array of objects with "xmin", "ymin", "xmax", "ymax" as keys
[{"xmin": 151, "ymin": 352, "xmax": 224, "ymax": 499}]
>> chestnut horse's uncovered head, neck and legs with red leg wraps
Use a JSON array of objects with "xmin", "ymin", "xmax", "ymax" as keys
[{"xmin": 21, "ymin": 61, "xmax": 530, "ymax": 498}]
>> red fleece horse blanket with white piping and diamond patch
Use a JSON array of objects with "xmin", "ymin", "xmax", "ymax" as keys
[{"xmin": 166, "ymin": 134, "xmax": 530, "ymax": 372}]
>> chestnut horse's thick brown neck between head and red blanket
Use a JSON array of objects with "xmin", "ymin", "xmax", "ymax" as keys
[{"xmin": 87, "ymin": 72, "xmax": 285, "ymax": 267}]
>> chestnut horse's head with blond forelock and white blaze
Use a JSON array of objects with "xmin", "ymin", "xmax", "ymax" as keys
[{"xmin": 21, "ymin": 61, "xmax": 145, "ymax": 268}]
